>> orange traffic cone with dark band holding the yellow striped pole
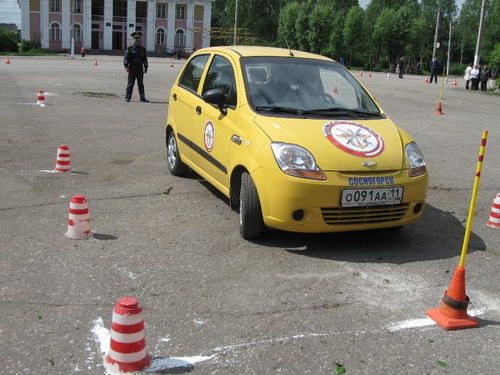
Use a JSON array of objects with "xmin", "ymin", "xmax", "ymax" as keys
[{"xmin": 426, "ymin": 266, "xmax": 479, "ymax": 330}]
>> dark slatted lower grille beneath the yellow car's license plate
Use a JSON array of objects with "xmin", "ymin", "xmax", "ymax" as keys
[{"xmin": 321, "ymin": 204, "xmax": 408, "ymax": 225}]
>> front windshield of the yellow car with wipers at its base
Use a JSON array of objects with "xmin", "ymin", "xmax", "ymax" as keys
[{"xmin": 241, "ymin": 56, "xmax": 383, "ymax": 117}]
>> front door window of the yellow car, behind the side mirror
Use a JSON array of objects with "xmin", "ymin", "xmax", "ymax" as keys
[{"xmin": 203, "ymin": 56, "xmax": 237, "ymax": 106}]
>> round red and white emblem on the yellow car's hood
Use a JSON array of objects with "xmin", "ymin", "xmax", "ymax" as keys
[{"xmin": 323, "ymin": 121, "xmax": 385, "ymax": 158}]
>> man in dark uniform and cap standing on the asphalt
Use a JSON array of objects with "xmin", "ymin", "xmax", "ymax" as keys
[{"xmin": 123, "ymin": 31, "xmax": 149, "ymax": 102}]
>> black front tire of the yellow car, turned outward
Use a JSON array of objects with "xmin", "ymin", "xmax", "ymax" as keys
[{"xmin": 240, "ymin": 172, "xmax": 264, "ymax": 240}]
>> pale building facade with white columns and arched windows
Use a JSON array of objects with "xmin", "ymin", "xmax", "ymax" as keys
[{"xmin": 18, "ymin": 0, "xmax": 215, "ymax": 53}]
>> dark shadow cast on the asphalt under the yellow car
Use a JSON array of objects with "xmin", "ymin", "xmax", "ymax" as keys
[{"xmin": 254, "ymin": 204, "xmax": 486, "ymax": 264}]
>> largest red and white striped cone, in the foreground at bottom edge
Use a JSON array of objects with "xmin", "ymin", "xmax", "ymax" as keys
[{"xmin": 104, "ymin": 297, "xmax": 151, "ymax": 374}]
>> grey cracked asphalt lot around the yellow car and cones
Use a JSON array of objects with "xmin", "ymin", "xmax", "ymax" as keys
[{"xmin": 0, "ymin": 56, "xmax": 500, "ymax": 375}]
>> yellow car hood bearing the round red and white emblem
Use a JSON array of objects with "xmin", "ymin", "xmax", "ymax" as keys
[{"xmin": 254, "ymin": 115, "xmax": 404, "ymax": 172}]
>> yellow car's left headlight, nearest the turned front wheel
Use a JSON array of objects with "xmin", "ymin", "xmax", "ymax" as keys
[{"xmin": 271, "ymin": 142, "xmax": 326, "ymax": 180}]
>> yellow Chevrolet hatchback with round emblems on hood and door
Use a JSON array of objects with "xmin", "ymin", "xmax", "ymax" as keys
[{"xmin": 166, "ymin": 46, "xmax": 428, "ymax": 239}]
